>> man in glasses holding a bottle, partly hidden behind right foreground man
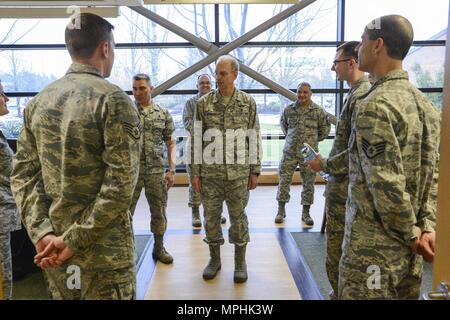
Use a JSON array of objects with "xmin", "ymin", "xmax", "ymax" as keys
[{"xmin": 306, "ymin": 41, "xmax": 370, "ymax": 300}]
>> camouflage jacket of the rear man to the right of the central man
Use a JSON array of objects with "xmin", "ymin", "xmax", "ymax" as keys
[{"xmin": 280, "ymin": 101, "xmax": 331, "ymax": 157}]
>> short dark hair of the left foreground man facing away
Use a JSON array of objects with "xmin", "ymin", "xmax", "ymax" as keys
[{"xmin": 65, "ymin": 13, "xmax": 114, "ymax": 59}]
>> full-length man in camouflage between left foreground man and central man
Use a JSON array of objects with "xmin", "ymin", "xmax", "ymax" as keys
[{"xmin": 130, "ymin": 74, "xmax": 176, "ymax": 264}]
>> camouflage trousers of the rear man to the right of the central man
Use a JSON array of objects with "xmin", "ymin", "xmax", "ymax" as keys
[{"xmin": 277, "ymin": 154, "xmax": 316, "ymax": 205}]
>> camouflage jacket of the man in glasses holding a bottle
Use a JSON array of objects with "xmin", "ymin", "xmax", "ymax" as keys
[{"xmin": 321, "ymin": 76, "xmax": 370, "ymax": 178}]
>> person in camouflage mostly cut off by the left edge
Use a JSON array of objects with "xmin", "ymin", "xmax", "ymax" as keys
[{"xmin": 0, "ymin": 81, "xmax": 21, "ymax": 300}]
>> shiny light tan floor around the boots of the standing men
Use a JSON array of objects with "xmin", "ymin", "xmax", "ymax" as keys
[{"xmin": 134, "ymin": 185, "xmax": 324, "ymax": 300}]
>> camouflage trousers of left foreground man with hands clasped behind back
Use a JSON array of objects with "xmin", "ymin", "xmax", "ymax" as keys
[{"xmin": 44, "ymin": 263, "xmax": 136, "ymax": 300}]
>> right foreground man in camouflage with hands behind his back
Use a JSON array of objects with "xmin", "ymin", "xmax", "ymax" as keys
[{"xmin": 338, "ymin": 15, "xmax": 440, "ymax": 299}]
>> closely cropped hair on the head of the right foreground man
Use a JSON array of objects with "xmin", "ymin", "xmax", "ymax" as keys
[{"xmin": 364, "ymin": 15, "xmax": 414, "ymax": 60}]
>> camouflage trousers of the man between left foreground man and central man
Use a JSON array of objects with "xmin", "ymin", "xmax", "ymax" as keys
[{"xmin": 130, "ymin": 170, "xmax": 167, "ymax": 236}]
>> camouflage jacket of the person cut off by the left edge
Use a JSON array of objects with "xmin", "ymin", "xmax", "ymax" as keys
[{"xmin": 0, "ymin": 131, "xmax": 21, "ymax": 233}]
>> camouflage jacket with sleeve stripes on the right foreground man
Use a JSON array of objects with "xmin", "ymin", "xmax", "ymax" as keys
[{"xmin": 346, "ymin": 70, "xmax": 440, "ymax": 246}]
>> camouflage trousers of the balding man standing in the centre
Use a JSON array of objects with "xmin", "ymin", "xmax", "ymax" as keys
[{"xmin": 202, "ymin": 178, "xmax": 250, "ymax": 245}]
